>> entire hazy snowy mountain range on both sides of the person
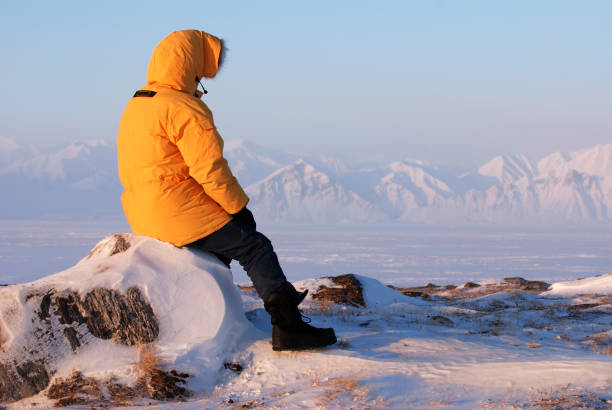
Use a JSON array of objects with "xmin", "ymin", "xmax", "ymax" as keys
[{"xmin": 0, "ymin": 137, "xmax": 612, "ymax": 226}]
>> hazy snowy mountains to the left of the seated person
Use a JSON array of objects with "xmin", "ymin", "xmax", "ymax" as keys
[{"xmin": 0, "ymin": 137, "xmax": 122, "ymax": 219}]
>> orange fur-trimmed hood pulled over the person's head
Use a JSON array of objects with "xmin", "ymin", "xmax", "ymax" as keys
[{"xmin": 147, "ymin": 30, "xmax": 223, "ymax": 94}]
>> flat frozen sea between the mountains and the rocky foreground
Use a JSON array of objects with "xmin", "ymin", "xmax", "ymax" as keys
[{"xmin": 0, "ymin": 220, "xmax": 612, "ymax": 286}]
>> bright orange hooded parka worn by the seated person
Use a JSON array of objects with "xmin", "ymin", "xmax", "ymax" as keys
[{"xmin": 117, "ymin": 30, "xmax": 249, "ymax": 246}]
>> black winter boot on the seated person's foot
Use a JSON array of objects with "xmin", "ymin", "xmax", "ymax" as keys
[{"xmin": 264, "ymin": 290, "xmax": 336, "ymax": 350}]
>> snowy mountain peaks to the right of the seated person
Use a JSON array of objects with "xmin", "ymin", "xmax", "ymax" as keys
[{"xmin": 241, "ymin": 144, "xmax": 612, "ymax": 226}]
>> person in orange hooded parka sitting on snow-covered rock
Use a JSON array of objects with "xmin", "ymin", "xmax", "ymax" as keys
[{"xmin": 117, "ymin": 30, "xmax": 336, "ymax": 350}]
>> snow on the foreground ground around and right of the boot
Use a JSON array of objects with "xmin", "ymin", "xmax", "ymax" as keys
[{"xmin": 180, "ymin": 270, "xmax": 612, "ymax": 409}]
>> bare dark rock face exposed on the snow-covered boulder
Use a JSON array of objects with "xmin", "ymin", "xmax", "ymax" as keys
[{"xmin": 0, "ymin": 287, "xmax": 159, "ymax": 404}]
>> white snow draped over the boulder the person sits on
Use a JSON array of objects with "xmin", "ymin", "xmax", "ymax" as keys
[{"xmin": 0, "ymin": 235, "xmax": 253, "ymax": 400}]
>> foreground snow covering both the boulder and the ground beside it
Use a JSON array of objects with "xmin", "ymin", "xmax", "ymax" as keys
[{"xmin": 0, "ymin": 235, "xmax": 612, "ymax": 409}]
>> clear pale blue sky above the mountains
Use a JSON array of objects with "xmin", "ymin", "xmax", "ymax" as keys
[{"xmin": 0, "ymin": 0, "xmax": 612, "ymax": 165}]
